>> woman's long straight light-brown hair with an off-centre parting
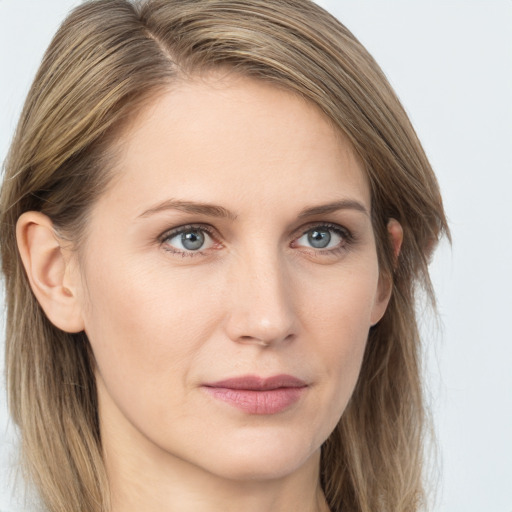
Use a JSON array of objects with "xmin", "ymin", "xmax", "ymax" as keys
[{"xmin": 0, "ymin": 0, "xmax": 448, "ymax": 512}]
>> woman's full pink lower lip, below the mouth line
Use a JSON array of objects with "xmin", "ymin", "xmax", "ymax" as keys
[{"xmin": 203, "ymin": 386, "xmax": 306, "ymax": 414}]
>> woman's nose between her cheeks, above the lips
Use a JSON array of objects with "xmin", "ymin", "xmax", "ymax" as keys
[{"xmin": 226, "ymin": 251, "xmax": 298, "ymax": 347}]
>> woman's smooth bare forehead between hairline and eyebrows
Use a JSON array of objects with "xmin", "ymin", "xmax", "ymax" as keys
[{"xmin": 96, "ymin": 75, "xmax": 370, "ymax": 218}]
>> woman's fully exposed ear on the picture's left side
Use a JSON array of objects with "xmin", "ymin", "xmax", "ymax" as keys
[{"xmin": 16, "ymin": 211, "xmax": 84, "ymax": 332}]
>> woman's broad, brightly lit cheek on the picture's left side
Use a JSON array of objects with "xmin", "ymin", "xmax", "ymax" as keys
[{"xmin": 80, "ymin": 252, "xmax": 219, "ymax": 410}]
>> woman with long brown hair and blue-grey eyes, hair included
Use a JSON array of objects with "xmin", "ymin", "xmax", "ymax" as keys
[{"xmin": 1, "ymin": 0, "xmax": 448, "ymax": 512}]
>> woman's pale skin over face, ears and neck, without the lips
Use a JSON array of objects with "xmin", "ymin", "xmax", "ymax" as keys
[{"xmin": 17, "ymin": 76, "xmax": 402, "ymax": 512}]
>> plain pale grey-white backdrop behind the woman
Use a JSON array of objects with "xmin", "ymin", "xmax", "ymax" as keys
[{"xmin": 0, "ymin": 0, "xmax": 512, "ymax": 512}]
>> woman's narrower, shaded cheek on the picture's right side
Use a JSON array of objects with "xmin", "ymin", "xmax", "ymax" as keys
[{"xmin": 301, "ymin": 259, "xmax": 378, "ymax": 424}]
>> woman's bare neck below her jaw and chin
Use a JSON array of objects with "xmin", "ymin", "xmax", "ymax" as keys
[{"xmin": 102, "ymin": 416, "xmax": 329, "ymax": 512}]
